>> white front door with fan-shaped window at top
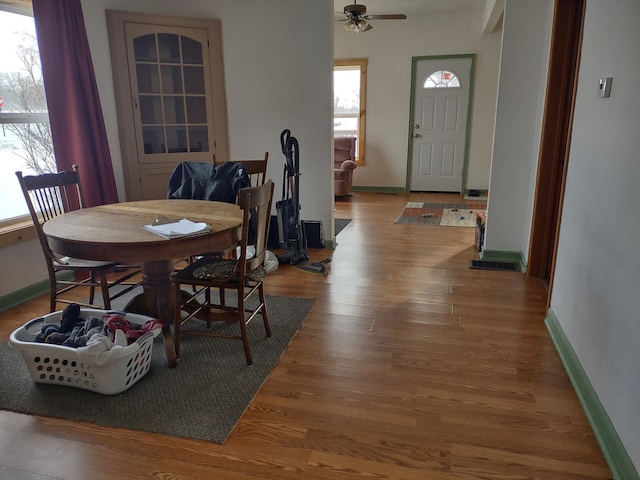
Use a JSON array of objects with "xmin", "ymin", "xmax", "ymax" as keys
[{"xmin": 410, "ymin": 56, "xmax": 473, "ymax": 192}]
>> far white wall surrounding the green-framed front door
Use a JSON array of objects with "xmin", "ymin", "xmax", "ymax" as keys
[{"xmin": 334, "ymin": 10, "xmax": 500, "ymax": 189}]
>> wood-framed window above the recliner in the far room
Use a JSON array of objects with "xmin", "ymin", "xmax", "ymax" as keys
[{"xmin": 333, "ymin": 58, "xmax": 367, "ymax": 164}]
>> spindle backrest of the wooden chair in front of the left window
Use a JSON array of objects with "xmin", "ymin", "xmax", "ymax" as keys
[{"xmin": 16, "ymin": 165, "xmax": 84, "ymax": 259}]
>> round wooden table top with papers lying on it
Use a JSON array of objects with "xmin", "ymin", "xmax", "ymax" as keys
[{"xmin": 43, "ymin": 199, "xmax": 242, "ymax": 262}]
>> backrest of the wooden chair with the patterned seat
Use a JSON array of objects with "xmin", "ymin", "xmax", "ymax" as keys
[{"xmin": 237, "ymin": 180, "xmax": 273, "ymax": 274}]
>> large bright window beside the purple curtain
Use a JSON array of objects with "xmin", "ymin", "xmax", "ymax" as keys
[{"xmin": 0, "ymin": 9, "xmax": 56, "ymax": 227}]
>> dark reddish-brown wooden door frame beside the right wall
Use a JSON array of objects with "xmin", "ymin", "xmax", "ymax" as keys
[{"xmin": 527, "ymin": 0, "xmax": 586, "ymax": 292}]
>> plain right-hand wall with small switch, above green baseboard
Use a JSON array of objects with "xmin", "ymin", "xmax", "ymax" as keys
[{"xmin": 551, "ymin": 0, "xmax": 640, "ymax": 471}]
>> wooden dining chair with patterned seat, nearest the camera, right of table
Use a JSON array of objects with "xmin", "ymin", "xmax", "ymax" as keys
[{"xmin": 171, "ymin": 180, "xmax": 273, "ymax": 365}]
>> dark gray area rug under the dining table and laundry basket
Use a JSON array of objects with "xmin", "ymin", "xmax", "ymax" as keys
[{"xmin": 0, "ymin": 288, "xmax": 315, "ymax": 443}]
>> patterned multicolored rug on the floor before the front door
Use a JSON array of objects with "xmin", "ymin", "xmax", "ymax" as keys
[{"xmin": 396, "ymin": 202, "xmax": 487, "ymax": 227}]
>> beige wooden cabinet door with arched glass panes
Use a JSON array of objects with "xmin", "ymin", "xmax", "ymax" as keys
[{"xmin": 108, "ymin": 12, "xmax": 227, "ymax": 200}]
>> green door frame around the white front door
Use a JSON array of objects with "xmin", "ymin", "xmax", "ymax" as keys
[{"xmin": 404, "ymin": 53, "xmax": 476, "ymax": 194}]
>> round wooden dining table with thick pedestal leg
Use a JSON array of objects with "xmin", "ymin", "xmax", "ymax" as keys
[{"xmin": 43, "ymin": 199, "xmax": 242, "ymax": 367}]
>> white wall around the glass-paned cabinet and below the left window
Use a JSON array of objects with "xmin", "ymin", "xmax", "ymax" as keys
[{"xmin": 0, "ymin": 0, "xmax": 333, "ymax": 297}]
